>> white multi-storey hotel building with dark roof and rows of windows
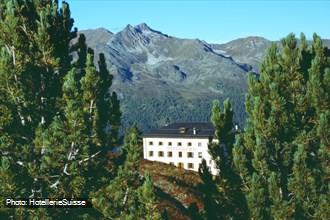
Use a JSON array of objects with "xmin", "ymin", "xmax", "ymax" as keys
[{"xmin": 143, "ymin": 123, "xmax": 217, "ymax": 175}]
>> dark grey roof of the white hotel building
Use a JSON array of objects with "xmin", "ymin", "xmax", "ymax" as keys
[{"xmin": 143, "ymin": 122, "xmax": 214, "ymax": 138}]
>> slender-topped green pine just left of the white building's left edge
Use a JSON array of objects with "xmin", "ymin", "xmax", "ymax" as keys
[{"xmin": 93, "ymin": 127, "xmax": 142, "ymax": 219}]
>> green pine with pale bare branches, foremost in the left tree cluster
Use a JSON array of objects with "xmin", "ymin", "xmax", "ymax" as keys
[{"xmin": 34, "ymin": 68, "xmax": 89, "ymax": 198}]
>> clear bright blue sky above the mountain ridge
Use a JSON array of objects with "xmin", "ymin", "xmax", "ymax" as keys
[{"xmin": 67, "ymin": 0, "xmax": 330, "ymax": 43}]
